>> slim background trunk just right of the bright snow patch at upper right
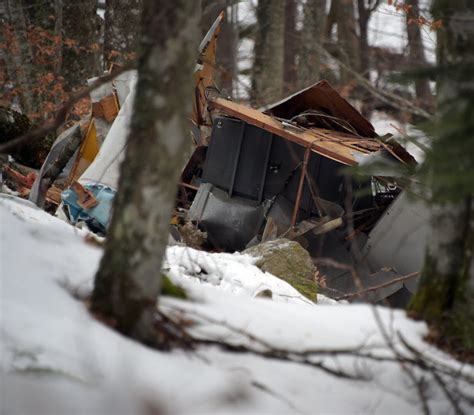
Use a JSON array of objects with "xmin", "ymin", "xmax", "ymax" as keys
[{"xmin": 406, "ymin": 0, "xmax": 433, "ymax": 112}]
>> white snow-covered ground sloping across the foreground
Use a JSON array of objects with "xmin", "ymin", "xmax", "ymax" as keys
[{"xmin": 0, "ymin": 195, "xmax": 472, "ymax": 414}]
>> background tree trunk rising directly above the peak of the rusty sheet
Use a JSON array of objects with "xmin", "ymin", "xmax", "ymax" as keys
[{"xmin": 298, "ymin": 0, "xmax": 326, "ymax": 87}]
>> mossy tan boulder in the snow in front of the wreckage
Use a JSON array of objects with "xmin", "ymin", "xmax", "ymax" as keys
[{"xmin": 242, "ymin": 239, "xmax": 318, "ymax": 301}]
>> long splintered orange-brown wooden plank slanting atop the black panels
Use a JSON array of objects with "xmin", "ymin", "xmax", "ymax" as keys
[{"xmin": 208, "ymin": 98, "xmax": 378, "ymax": 165}]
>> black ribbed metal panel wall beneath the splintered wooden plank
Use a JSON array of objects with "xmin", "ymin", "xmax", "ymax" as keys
[{"xmin": 203, "ymin": 117, "xmax": 343, "ymax": 219}]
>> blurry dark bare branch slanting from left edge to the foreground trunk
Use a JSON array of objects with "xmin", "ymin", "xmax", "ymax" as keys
[{"xmin": 0, "ymin": 64, "xmax": 134, "ymax": 153}]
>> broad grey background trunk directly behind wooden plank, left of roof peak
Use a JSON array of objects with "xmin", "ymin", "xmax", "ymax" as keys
[{"xmin": 251, "ymin": 0, "xmax": 285, "ymax": 105}]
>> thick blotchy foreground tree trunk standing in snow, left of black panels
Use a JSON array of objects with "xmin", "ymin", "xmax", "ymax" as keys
[{"xmin": 92, "ymin": 0, "xmax": 199, "ymax": 345}]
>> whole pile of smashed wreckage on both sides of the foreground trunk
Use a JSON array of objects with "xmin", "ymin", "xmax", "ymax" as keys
[{"xmin": 0, "ymin": 16, "xmax": 427, "ymax": 306}]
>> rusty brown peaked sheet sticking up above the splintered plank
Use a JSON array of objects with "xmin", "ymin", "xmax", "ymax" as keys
[{"xmin": 262, "ymin": 80, "xmax": 377, "ymax": 137}]
